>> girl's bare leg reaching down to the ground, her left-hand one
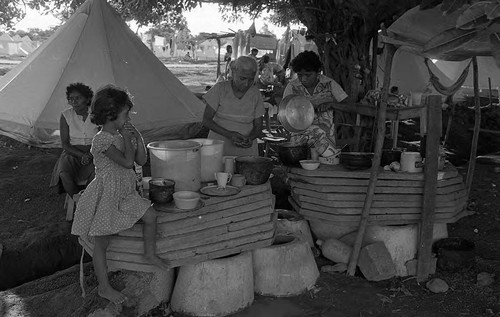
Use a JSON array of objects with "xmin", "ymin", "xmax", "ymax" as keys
[{"xmin": 92, "ymin": 236, "xmax": 127, "ymax": 304}]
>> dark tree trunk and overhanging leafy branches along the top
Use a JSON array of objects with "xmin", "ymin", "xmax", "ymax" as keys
[{"xmin": 0, "ymin": 0, "xmax": 500, "ymax": 99}]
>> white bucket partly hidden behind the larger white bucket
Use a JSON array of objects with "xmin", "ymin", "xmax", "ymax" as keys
[{"xmin": 190, "ymin": 139, "xmax": 224, "ymax": 182}]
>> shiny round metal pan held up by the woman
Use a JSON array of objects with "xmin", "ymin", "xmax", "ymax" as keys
[{"xmin": 278, "ymin": 95, "xmax": 314, "ymax": 133}]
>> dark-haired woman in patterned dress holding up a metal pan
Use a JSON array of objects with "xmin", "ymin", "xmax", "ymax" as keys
[{"xmin": 283, "ymin": 51, "xmax": 347, "ymax": 157}]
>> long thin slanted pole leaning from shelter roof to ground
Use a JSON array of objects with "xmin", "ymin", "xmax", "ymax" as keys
[{"xmin": 347, "ymin": 40, "xmax": 396, "ymax": 276}]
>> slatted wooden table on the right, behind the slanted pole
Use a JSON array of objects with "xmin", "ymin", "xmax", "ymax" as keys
[{"xmin": 288, "ymin": 164, "xmax": 470, "ymax": 225}]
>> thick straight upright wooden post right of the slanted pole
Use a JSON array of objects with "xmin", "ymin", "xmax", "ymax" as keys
[{"xmin": 417, "ymin": 95, "xmax": 442, "ymax": 282}]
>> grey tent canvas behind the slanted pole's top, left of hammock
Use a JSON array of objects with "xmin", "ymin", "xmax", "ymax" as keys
[{"xmin": 377, "ymin": 49, "xmax": 453, "ymax": 94}]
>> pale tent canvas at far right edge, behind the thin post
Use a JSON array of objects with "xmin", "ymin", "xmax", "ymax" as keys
[{"xmin": 435, "ymin": 56, "xmax": 500, "ymax": 89}]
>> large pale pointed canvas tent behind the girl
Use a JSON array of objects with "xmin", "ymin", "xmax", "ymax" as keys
[{"xmin": 0, "ymin": 0, "xmax": 204, "ymax": 147}]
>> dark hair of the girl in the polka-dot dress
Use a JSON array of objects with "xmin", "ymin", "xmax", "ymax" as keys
[{"xmin": 90, "ymin": 84, "xmax": 134, "ymax": 125}]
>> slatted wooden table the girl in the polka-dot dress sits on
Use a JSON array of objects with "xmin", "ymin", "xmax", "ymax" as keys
[{"xmin": 79, "ymin": 182, "xmax": 277, "ymax": 272}]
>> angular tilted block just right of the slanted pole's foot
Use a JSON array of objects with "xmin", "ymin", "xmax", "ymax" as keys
[{"xmin": 358, "ymin": 242, "xmax": 396, "ymax": 281}]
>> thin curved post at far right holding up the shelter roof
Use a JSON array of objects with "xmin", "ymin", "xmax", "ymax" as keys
[{"xmin": 465, "ymin": 56, "xmax": 481, "ymax": 197}]
